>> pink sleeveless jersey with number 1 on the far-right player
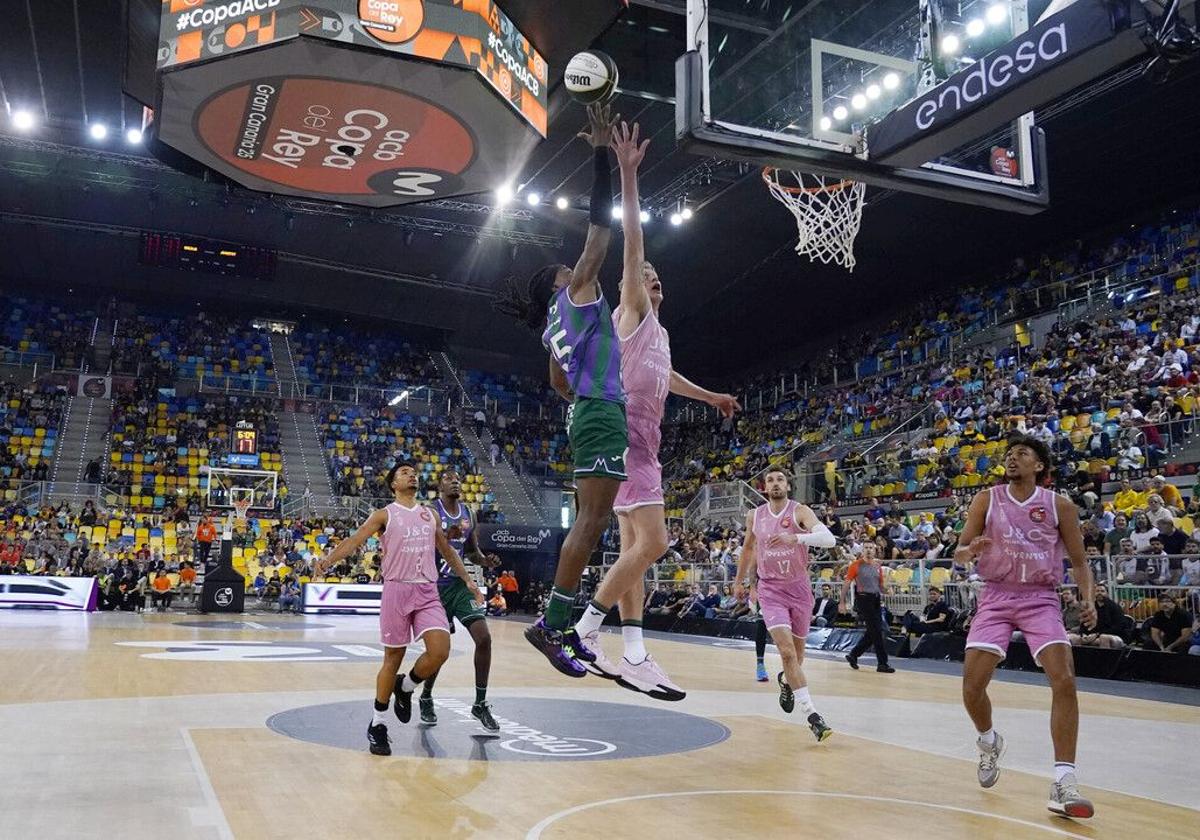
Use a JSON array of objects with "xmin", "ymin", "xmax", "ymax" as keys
[{"xmin": 978, "ymin": 484, "xmax": 1067, "ymax": 587}]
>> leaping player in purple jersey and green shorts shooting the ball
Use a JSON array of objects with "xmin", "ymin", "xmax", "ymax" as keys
[{"xmin": 496, "ymin": 106, "xmax": 649, "ymax": 677}]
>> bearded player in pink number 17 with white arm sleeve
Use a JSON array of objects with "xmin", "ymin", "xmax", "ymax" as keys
[{"xmin": 737, "ymin": 469, "xmax": 835, "ymax": 742}]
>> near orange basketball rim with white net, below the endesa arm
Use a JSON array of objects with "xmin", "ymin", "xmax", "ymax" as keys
[{"xmin": 762, "ymin": 167, "xmax": 866, "ymax": 271}]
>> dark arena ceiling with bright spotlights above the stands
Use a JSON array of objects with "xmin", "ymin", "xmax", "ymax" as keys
[{"xmin": 0, "ymin": 0, "xmax": 1200, "ymax": 376}]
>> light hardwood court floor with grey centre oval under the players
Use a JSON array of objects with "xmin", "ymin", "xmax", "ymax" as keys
[{"xmin": 0, "ymin": 612, "xmax": 1200, "ymax": 840}]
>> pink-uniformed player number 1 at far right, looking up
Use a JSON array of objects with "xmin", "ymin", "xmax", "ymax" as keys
[{"xmin": 954, "ymin": 436, "xmax": 1096, "ymax": 817}]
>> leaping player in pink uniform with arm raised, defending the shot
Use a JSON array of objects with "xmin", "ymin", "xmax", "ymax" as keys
[{"xmin": 575, "ymin": 253, "xmax": 740, "ymax": 701}]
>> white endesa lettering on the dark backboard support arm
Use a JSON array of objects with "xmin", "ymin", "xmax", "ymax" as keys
[{"xmin": 913, "ymin": 23, "xmax": 1069, "ymax": 131}]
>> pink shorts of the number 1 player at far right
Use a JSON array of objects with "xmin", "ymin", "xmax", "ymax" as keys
[{"xmin": 967, "ymin": 583, "xmax": 1070, "ymax": 662}]
